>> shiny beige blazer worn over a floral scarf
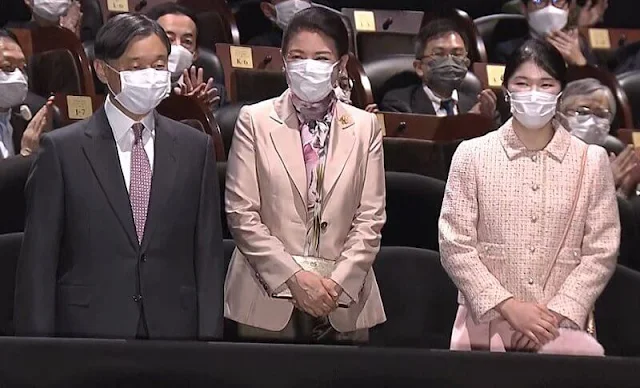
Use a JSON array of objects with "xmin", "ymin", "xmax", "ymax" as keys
[{"xmin": 225, "ymin": 91, "xmax": 386, "ymax": 332}]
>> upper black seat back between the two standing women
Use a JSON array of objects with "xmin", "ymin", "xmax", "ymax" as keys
[{"xmin": 382, "ymin": 171, "xmax": 445, "ymax": 251}]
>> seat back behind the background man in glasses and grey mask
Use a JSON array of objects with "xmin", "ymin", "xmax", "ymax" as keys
[{"xmin": 363, "ymin": 55, "xmax": 482, "ymax": 103}]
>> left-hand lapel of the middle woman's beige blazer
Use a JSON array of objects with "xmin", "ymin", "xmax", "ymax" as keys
[{"xmin": 270, "ymin": 92, "xmax": 307, "ymax": 202}]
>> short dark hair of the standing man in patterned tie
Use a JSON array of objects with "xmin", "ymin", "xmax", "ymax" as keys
[{"xmin": 94, "ymin": 13, "xmax": 171, "ymax": 61}]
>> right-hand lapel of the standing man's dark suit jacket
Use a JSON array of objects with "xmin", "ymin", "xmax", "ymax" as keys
[{"xmin": 141, "ymin": 114, "xmax": 178, "ymax": 252}]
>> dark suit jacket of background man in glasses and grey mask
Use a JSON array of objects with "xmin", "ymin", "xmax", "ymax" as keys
[{"xmin": 380, "ymin": 84, "xmax": 478, "ymax": 115}]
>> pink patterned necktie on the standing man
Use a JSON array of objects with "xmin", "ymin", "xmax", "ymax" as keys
[{"xmin": 129, "ymin": 123, "xmax": 151, "ymax": 243}]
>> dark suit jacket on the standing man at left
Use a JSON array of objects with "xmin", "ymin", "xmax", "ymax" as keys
[{"xmin": 14, "ymin": 108, "xmax": 225, "ymax": 339}]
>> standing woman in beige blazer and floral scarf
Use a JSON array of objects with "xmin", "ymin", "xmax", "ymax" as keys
[{"xmin": 225, "ymin": 7, "xmax": 386, "ymax": 343}]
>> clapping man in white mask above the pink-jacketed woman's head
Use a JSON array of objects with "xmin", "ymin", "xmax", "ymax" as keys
[{"xmin": 495, "ymin": 0, "xmax": 597, "ymax": 66}]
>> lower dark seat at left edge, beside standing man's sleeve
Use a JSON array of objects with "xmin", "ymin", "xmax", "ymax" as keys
[{"xmin": 0, "ymin": 233, "xmax": 22, "ymax": 335}]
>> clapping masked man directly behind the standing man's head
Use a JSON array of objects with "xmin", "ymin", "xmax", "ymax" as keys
[{"xmin": 147, "ymin": 2, "xmax": 226, "ymax": 111}]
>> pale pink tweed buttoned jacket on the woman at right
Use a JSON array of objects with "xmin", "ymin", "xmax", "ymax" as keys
[{"xmin": 439, "ymin": 121, "xmax": 620, "ymax": 328}]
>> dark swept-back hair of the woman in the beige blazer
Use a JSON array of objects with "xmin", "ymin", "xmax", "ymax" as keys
[{"xmin": 282, "ymin": 7, "xmax": 349, "ymax": 57}]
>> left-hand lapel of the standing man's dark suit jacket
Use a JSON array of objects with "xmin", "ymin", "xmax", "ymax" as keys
[{"xmin": 82, "ymin": 108, "xmax": 138, "ymax": 248}]
